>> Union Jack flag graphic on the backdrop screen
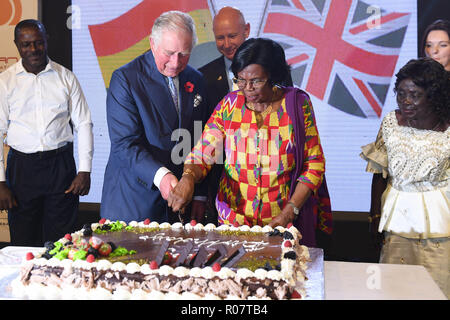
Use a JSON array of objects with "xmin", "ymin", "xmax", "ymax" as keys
[{"xmin": 259, "ymin": 0, "xmax": 410, "ymax": 118}]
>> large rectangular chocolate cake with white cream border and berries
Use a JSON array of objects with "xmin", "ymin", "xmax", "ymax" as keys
[{"xmin": 12, "ymin": 219, "xmax": 309, "ymax": 299}]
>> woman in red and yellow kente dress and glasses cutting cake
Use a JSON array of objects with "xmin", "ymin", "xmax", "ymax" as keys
[{"xmin": 168, "ymin": 38, "xmax": 332, "ymax": 247}]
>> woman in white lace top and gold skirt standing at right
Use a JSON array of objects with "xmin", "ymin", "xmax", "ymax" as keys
[{"xmin": 361, "ymin": 58, "xmax": 450, "ymax": 298}]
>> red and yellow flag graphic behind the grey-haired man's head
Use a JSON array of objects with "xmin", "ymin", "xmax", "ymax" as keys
[{"xmin": 89, "ymin": 0, "xmax": 214, "ymax": 88}]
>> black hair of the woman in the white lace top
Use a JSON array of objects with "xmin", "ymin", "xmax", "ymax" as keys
[{"xmin": 394, "ymin": 58, "xmax": 450, "ymax": 122}]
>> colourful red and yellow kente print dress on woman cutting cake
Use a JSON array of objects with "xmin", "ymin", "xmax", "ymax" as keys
[{"xmin": 185, "ymin": 91, "xmax": 325, "ymax": 226}]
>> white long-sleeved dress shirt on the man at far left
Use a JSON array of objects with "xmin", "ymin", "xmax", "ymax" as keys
[{"xmin": 0, "ymin": 59, "xmax": 94, "ymax": 181}]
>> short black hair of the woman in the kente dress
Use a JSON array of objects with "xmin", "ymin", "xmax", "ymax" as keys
[{"xmin": 231, "ymin": 38, "xmax": 291, "ymax": 86}]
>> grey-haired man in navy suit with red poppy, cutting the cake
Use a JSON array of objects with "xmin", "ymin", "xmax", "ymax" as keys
[{"xmin": 101, "ymin": 11, "xmax": 208, "ymax": 222}]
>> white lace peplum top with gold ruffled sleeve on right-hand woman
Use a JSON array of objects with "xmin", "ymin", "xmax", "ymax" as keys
[{"xmin": 361, "ymin": 111, "xmax": 450, "ymax": 239}]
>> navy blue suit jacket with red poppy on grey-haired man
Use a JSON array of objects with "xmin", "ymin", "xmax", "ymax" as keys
[{"xmin": 100, "ymin": 51, "xmax": 209, "ymax": 222}]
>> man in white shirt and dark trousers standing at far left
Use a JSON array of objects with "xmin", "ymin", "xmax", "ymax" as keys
[{"xmin": 0, "ymin": 20, "xmax": 93, "ymax": 246}]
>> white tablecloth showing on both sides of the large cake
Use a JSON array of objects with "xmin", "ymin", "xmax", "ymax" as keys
[{"xmin": 0, "ymin": 247, "xmax": 446, "ymax": 300}]
